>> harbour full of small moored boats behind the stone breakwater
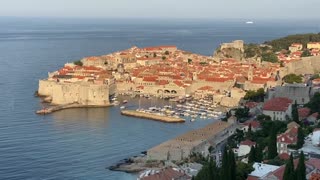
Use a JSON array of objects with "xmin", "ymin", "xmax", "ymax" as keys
[{"xmin": 114, "ymin": 95, "xmax": 227, "ymax": 122}]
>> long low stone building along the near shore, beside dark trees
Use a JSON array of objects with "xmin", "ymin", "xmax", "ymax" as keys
[{"xmin": 147, "ymin": 119, "xmax": 236, "ymax": 161}]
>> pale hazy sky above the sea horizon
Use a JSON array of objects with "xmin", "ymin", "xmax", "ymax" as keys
[{"xmin": 0, "ymin": 0, "xmax": 320, "ymax": 19}]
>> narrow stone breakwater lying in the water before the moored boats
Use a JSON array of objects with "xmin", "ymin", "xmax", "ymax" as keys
[{"xmin": 121, "ymin": 110, "xmax": 185, "ymax": 123}]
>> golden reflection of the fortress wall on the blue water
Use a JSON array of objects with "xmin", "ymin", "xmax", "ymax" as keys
[{"xmin": 52, "ymin": 108, "xmax": 110, "ymax": 128}]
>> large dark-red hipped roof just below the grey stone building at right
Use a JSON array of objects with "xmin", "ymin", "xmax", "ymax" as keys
[{"xmin": 263, "ymin": 97, "xmax": 292, "ymax": 111}]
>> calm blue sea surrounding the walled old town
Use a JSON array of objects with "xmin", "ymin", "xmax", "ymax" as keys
[{"xmin": 0, "ymin": 18, "xmax": 320, "ymax": 180}]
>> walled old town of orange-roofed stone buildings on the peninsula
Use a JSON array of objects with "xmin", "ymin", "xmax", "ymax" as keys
[{"xmin": 37, "ymin": 34, "xmax": 320, "ymax": 112}]
